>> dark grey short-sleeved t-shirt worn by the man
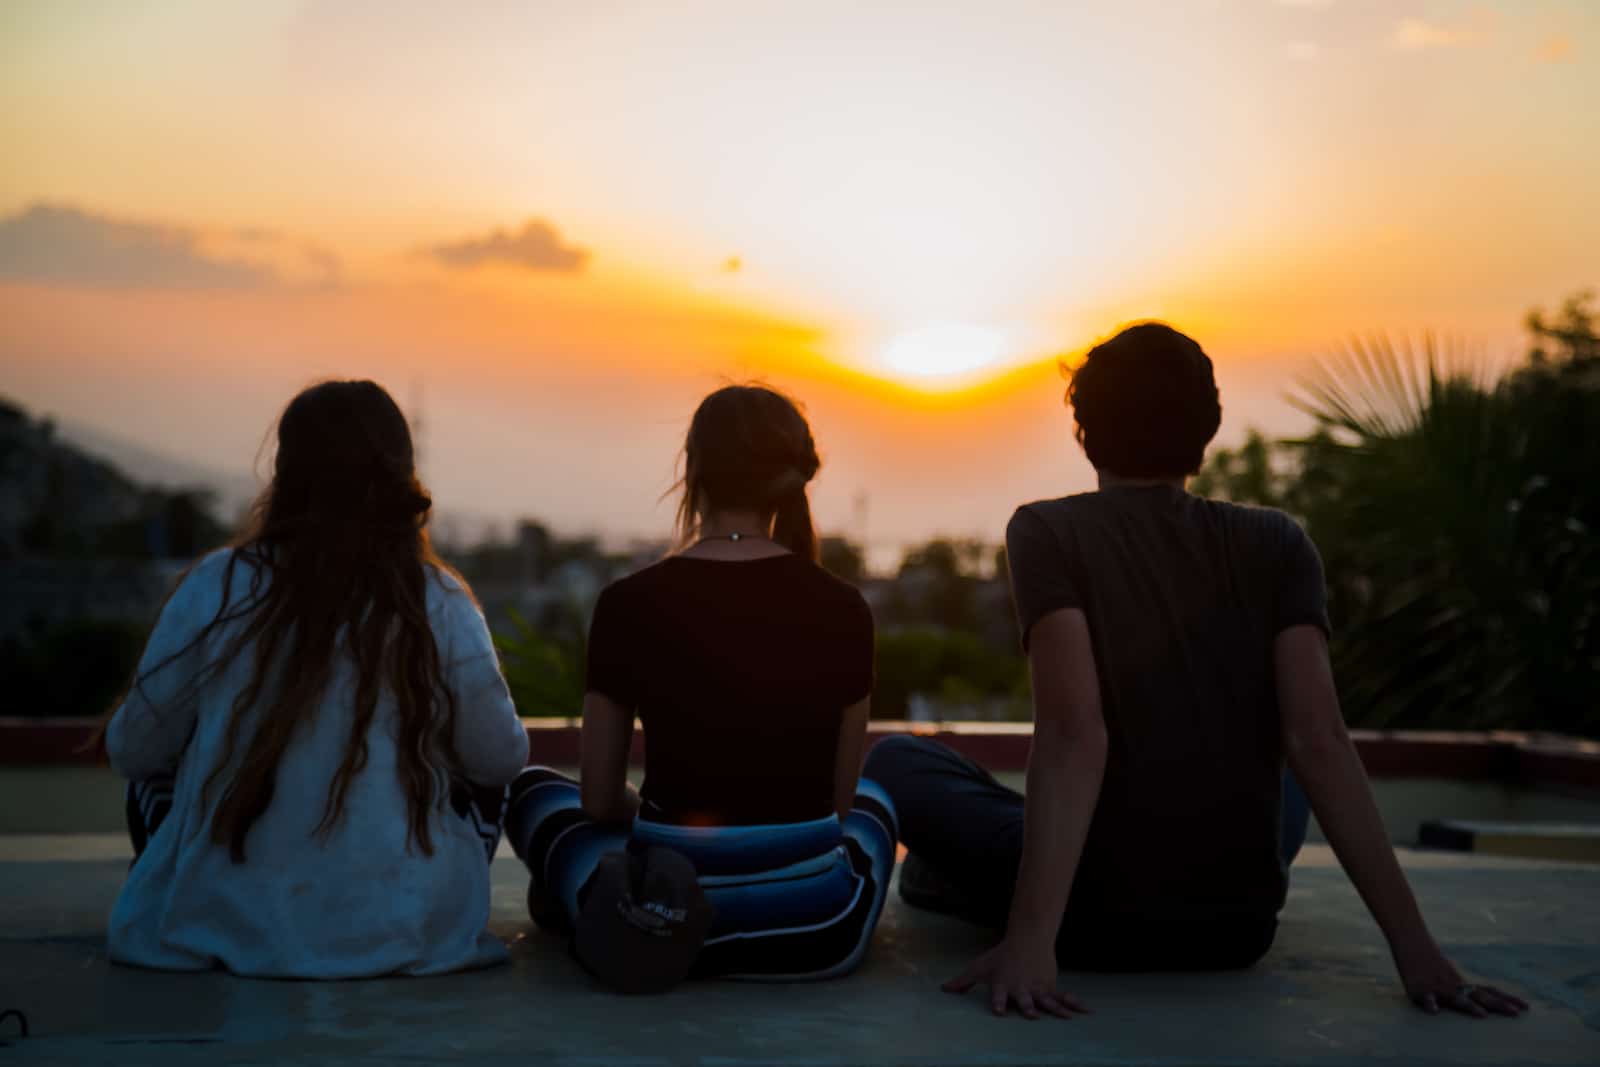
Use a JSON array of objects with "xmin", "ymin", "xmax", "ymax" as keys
[{"xmin": 1006, "ymin": 486, "xmax": 1328, "ymax": 918}]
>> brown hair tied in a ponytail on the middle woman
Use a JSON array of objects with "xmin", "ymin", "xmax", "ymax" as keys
[{"xmin": 677, "ymin": 386, "xmax": 822, "ymax": 563}]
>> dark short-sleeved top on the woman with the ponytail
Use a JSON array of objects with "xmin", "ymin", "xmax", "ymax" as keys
[{"xmin": 587, "ymin": 555, "xmax": 872, "ymax": 825}]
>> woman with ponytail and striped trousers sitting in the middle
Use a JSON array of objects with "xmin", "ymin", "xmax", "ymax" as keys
[{"xmin": 507, "ymin": 386, "xmax": 896, "ymax": 979}]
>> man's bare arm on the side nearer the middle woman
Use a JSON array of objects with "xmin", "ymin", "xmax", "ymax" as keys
[{"xmin": 946, "ymin": 608, "xmax": 1107, "ymax": 1019}]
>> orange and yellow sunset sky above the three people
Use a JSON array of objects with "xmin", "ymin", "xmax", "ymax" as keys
[{"xmin": 0, "ymin": 0, "xmax": 1600, "ymax": 542}]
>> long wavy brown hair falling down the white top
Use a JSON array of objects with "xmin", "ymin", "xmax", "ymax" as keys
[{"xmin": 112, "ymin": 381, "xmax": 466, "ymax": 862}]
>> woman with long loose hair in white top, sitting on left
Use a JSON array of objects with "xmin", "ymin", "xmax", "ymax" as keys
[{"xmin": 106, "ymin": 381, "xmax": 528, "ymax": 977}]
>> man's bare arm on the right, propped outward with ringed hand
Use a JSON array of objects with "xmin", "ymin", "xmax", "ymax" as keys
[{"xmin": 1272, "ymin": 625, "xmax": 1526, "ymax": 1016}]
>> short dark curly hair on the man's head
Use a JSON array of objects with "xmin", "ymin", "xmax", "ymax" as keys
[{"xmin": 1067, "ymin": 322, "xmax": 1222, "ymax": 478}]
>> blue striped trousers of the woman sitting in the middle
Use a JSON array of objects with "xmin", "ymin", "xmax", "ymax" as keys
[{"xmin": 506, "ymin": 766, "xmax": 898, "ymax": 981}]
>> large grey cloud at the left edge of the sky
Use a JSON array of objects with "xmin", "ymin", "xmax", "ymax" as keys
[{"xmin": 0, "ymin": 203, "xmax": 278, "ymax": 290}]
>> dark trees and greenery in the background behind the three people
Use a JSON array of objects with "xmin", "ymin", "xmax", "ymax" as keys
[{"xmin": 0, "ymin": 293, "xmax": 1600, "ymax": 736}]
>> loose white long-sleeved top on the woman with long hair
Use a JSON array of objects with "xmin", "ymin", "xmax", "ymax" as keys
[{"xmin": 106, "ymin": 549, "xmax": 528, "ymax": 979}]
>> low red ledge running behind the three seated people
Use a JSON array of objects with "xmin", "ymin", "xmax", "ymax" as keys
[{"xmin": 0, "ymin": 717, "xmax": 1600, "ymax": 790}]
